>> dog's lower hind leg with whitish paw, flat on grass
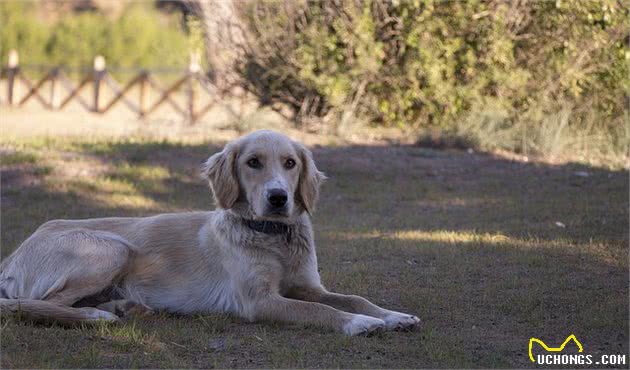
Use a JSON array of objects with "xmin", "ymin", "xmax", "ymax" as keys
[{"xmin": 0, "ymin": 298, "xmax": 119, "ymax": 324}]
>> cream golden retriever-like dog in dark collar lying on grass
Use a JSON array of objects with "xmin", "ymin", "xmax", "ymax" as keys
[{"xmin": 0, "ymin": 130, "xmax": 419, "ymax": 335}]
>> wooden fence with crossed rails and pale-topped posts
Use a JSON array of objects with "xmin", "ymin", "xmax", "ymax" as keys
[{"xmin": 0, "ymin": 50, "xmax": 238, "ymax": 123}]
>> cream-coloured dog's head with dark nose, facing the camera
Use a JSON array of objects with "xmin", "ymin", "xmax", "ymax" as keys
[{"xmin": 202, "ymin": 130, "xmax": 325, "ymax": 221}]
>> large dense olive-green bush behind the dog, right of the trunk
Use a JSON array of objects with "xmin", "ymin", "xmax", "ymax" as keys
[{"xmin": 241, "ymin": 0, "xmax": 630, "ymax": 165}]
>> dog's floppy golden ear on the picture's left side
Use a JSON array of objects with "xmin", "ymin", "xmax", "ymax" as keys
[{"xmin": 201, "ymin": 144, "xmax": 239, "ymax": 209}]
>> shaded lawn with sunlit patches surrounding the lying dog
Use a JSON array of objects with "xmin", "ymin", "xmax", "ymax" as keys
[{"xmin": 0, "ymin": 132, "xmax": 629, "ymax": 368}]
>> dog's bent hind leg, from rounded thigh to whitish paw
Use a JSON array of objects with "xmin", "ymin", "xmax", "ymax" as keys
[{"xmin": 0, "ymin": 229, "xmax": 133, "ymax": 322}]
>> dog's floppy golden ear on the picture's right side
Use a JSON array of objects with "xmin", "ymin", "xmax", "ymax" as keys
[{"xmin": 295, "ymin": 143, "xmax": 326, "ymax": 214}]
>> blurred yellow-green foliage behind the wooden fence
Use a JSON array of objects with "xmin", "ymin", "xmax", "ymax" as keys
[{"xmin": 0, "ymin": 1, "xmax": 191, "ymax": 68}]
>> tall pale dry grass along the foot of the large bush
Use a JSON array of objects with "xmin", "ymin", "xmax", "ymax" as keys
[{"xmin": 417, "ymin": 107, "xmax": 630, "ymax": 170}]
